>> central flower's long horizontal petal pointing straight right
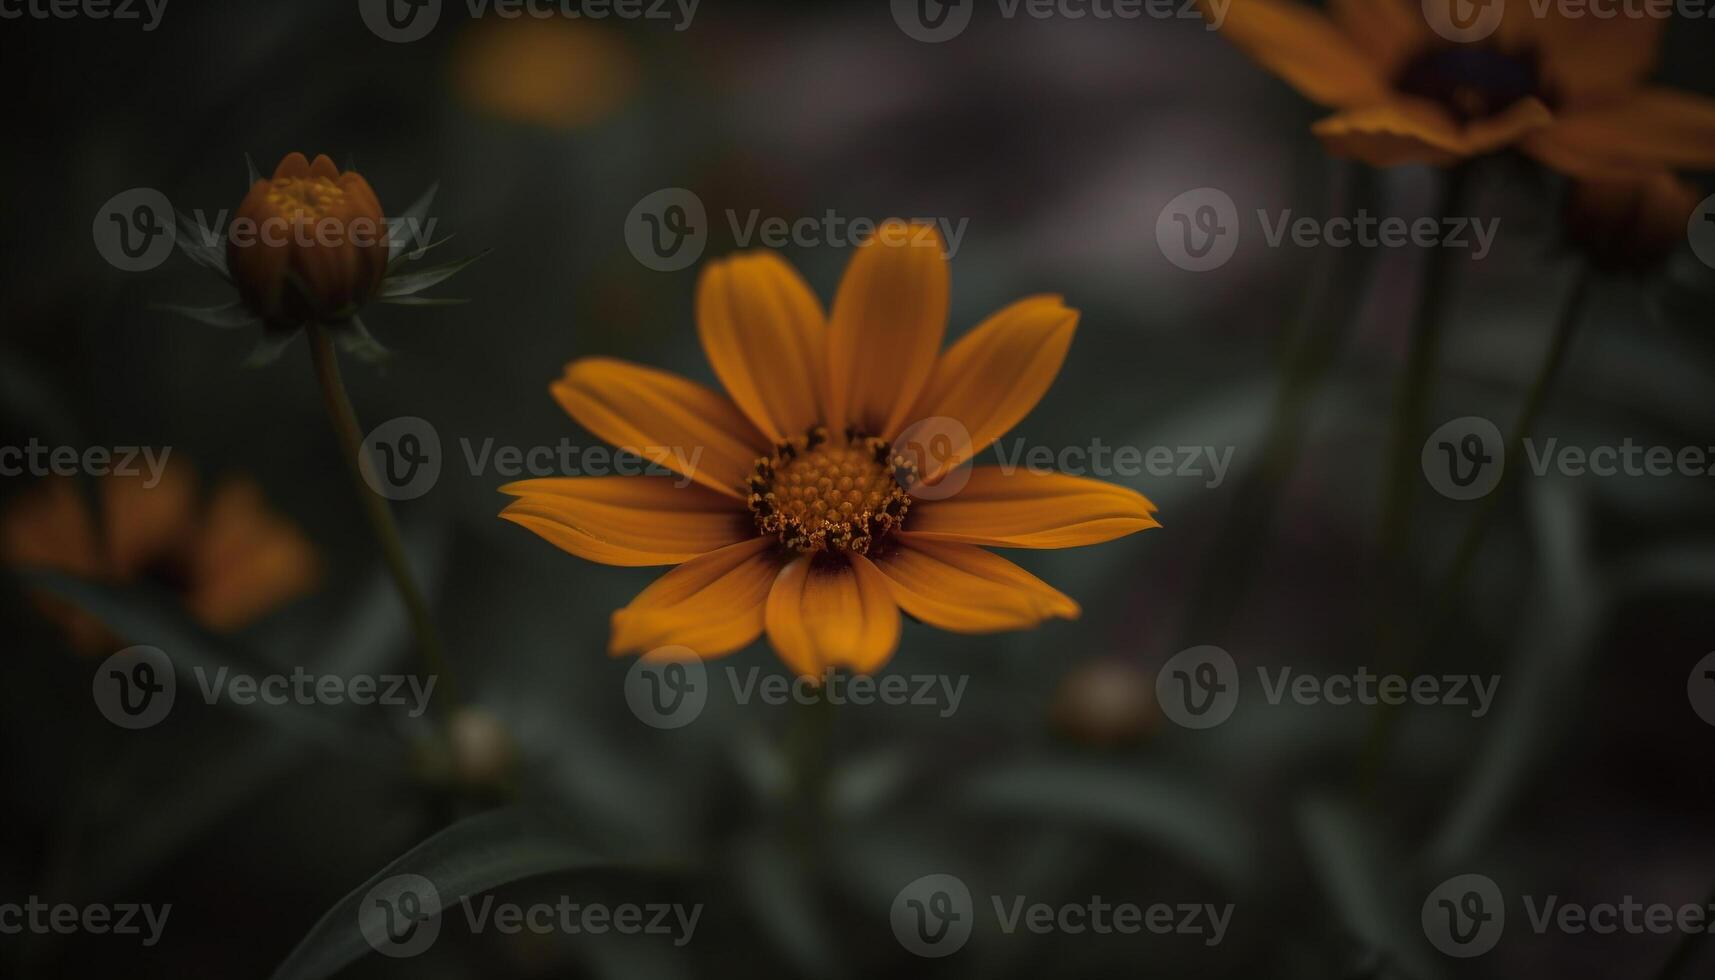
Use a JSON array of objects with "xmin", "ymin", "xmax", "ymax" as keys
[{"xmin": 906, "ymin": 467, "xmax": 1161, "ymax": 547}]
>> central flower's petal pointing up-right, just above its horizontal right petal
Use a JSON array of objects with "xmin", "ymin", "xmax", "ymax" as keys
[{"xmin": 907, "ymin": 295, "xmax": 1077, "ymax": 482}]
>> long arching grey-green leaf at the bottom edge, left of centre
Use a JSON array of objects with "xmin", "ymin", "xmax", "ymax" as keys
[{"xmin": 265, "ymin": 808, "xmax": 671, "ymax": 980}]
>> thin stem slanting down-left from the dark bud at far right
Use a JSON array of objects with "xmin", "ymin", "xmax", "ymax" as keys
[{"xmin": 1360, "ymin": 264, "xmax": 1592, "ymax": 791}]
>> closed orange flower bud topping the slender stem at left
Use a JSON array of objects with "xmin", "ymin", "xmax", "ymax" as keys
[{"xmin": 226, "ymin": 153, "xmax": 389, "ymax": 326}]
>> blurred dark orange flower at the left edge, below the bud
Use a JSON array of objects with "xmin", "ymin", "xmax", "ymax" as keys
[{"xmin": 0, "ymin": 462, "xmax": 317, "ymax": 652}]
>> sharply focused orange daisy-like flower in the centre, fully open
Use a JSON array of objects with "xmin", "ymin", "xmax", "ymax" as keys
[{"xmin": 501, "ymin": 221, "xmax": 1158, "ymax": 678}]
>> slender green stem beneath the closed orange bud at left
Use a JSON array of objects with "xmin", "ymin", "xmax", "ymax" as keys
[{"xmin": 305, "ymin": 323, "xmax": 458, "ymax": 714}]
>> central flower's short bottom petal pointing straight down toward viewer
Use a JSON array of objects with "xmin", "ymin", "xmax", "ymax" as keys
[{"xmin": 765, "ymin": 554, "xmax": 899, "ymax": 678}]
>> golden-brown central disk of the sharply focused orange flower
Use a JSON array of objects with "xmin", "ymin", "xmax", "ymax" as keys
[{"xmin": 749, "ymin": 427, "xmax": 914, "ymax": 554}]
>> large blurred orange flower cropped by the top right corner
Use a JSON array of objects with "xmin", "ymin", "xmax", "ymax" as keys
[{"xmin": 1221, "ymin": 0, "xmax": 1715, "ymax": 173}]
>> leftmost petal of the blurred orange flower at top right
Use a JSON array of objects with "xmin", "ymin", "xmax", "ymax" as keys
[{"xmin": 1202, "ymin": 0, "xmax": 1387, "ymax": 108}]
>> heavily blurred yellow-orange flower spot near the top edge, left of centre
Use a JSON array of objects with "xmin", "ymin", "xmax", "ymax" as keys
[{"xmin": 453, "ymin": 17, "xmax": 638, "ymax": 129}]
